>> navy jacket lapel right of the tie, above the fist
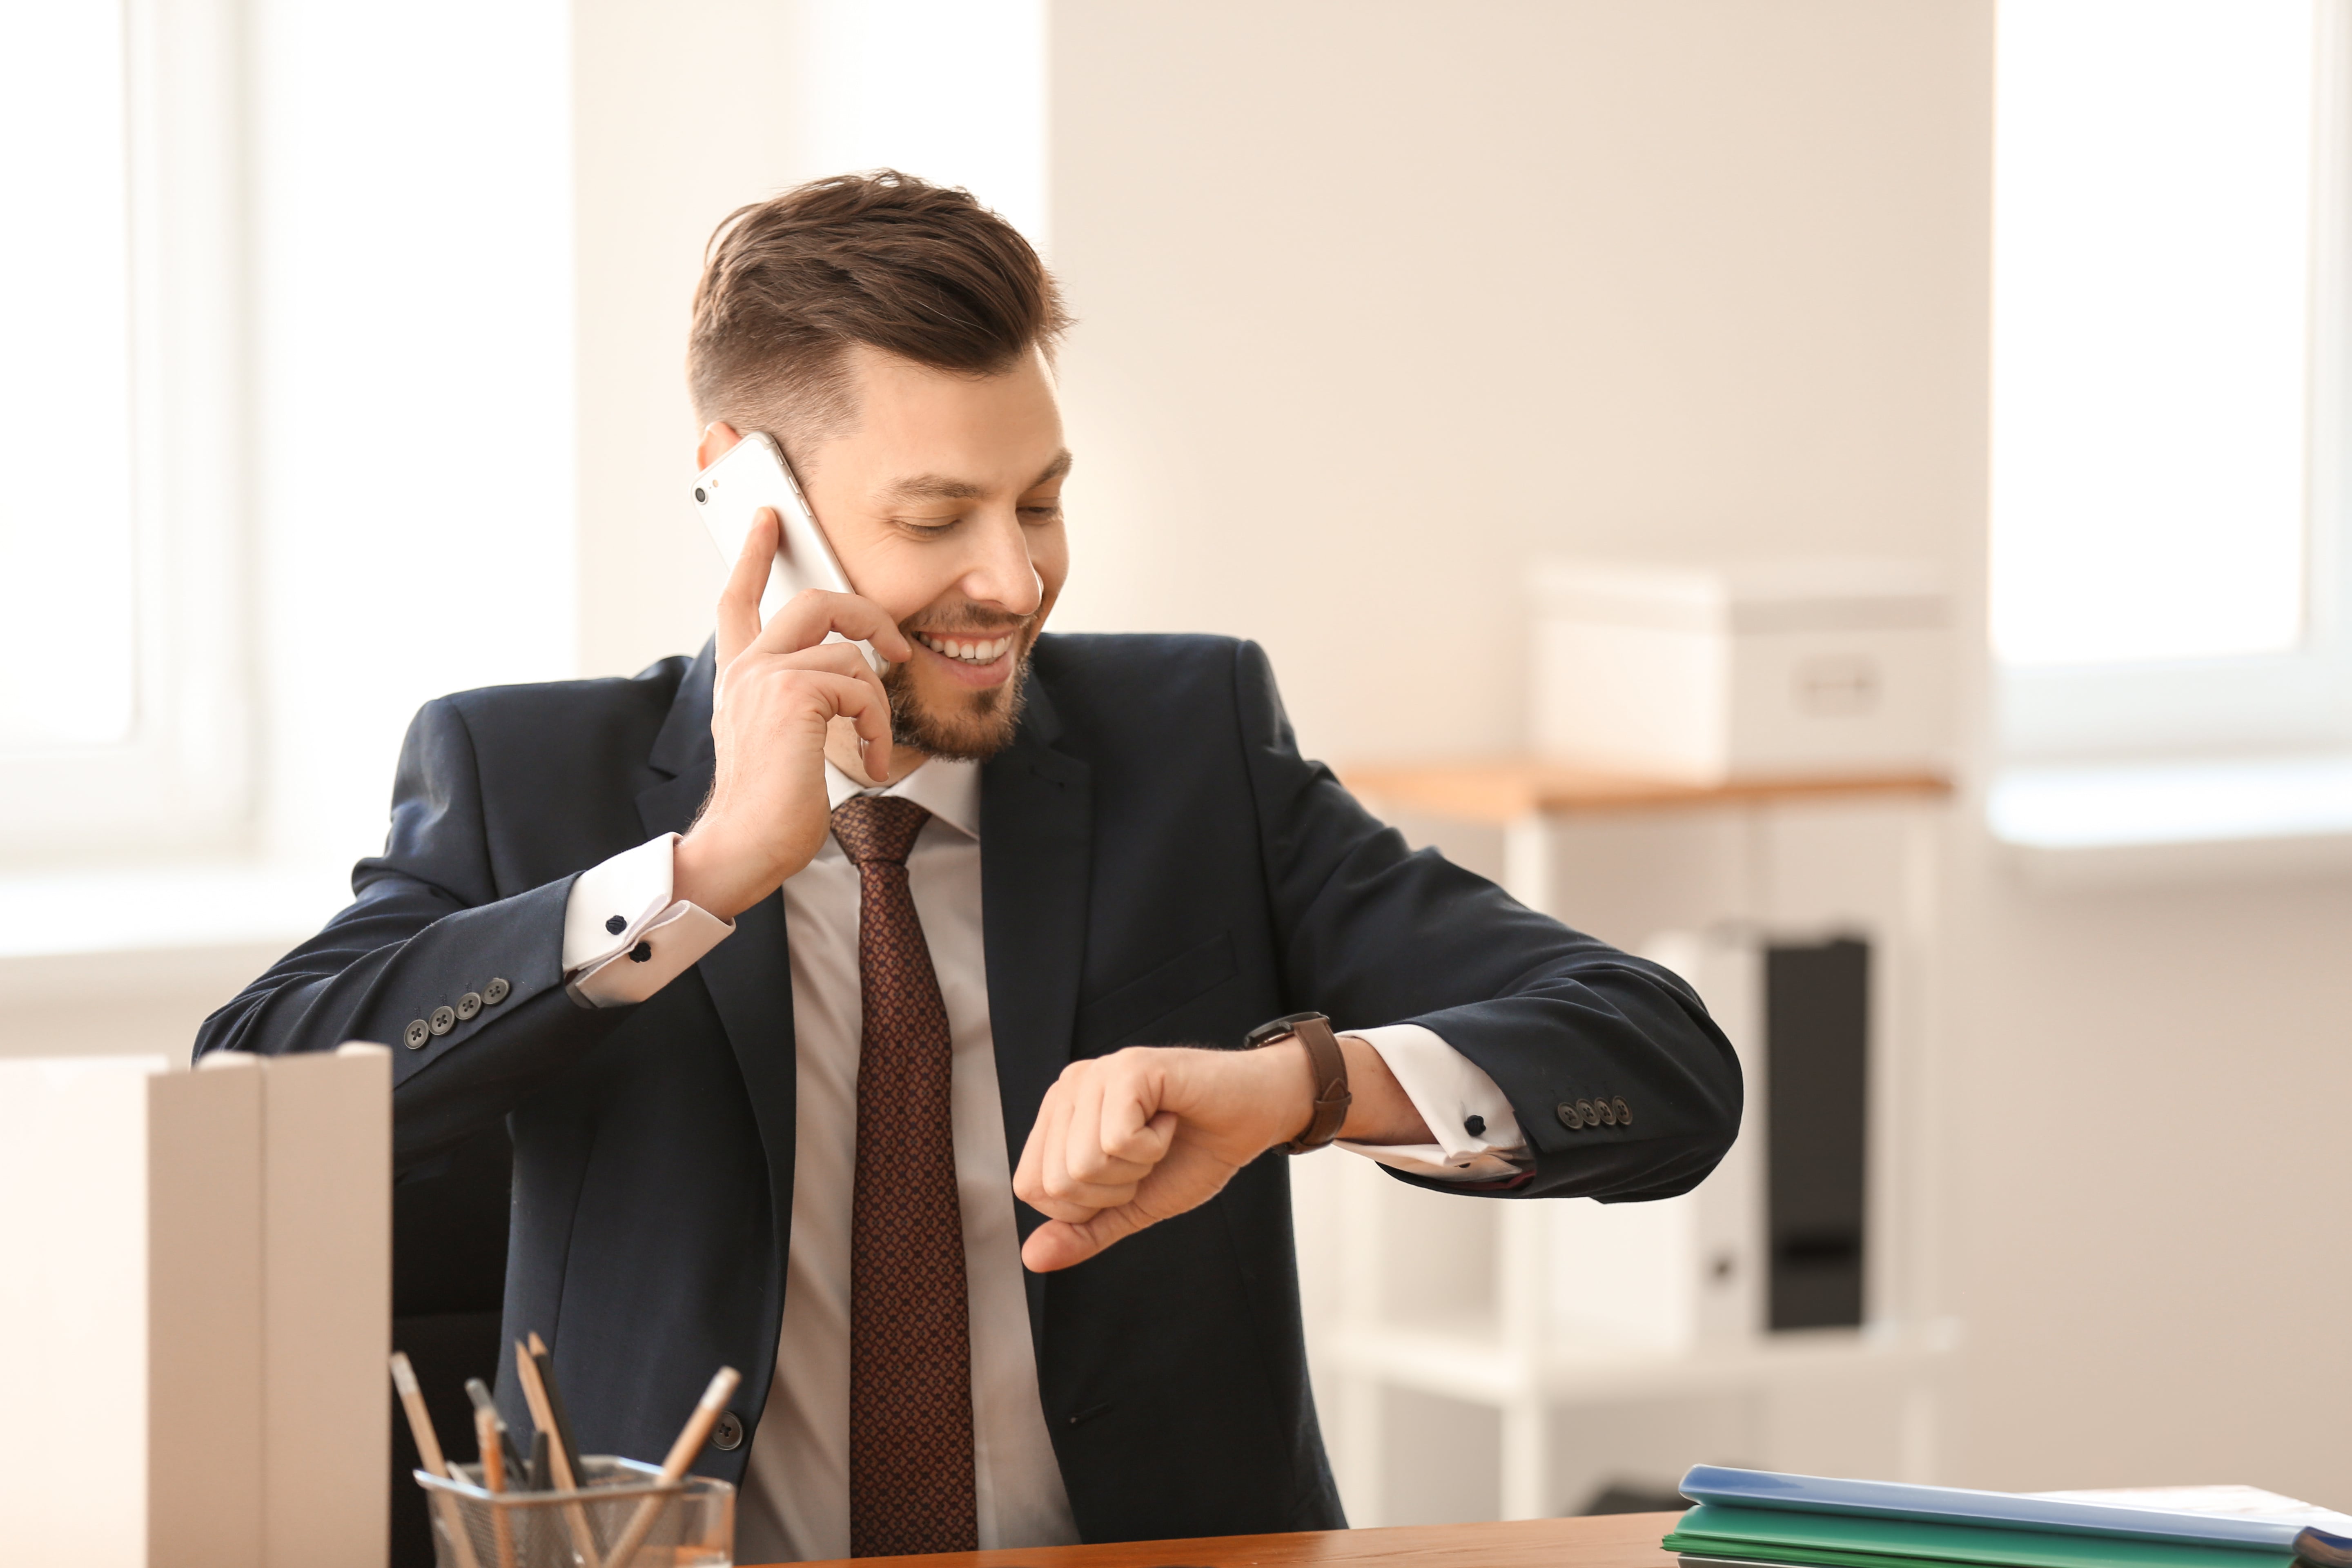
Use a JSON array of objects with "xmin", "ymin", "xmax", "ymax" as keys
[{"xmin": 981, "ymin": 670, "xmax": 1094, "ymax": 1328}]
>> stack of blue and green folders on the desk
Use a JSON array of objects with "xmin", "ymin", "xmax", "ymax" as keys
[{"xmin": 1661, "ymin": 1465, "xmax": 2352, "ymax": 1568}]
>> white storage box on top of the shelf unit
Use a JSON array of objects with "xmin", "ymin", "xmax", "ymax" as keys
[{"xmin": 1529, "ymin": 562, "xmax": 1952, "ymax": 783}]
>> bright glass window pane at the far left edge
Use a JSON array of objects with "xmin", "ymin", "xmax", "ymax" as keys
[{"xmin": 0, "ymin": 2, "xmax": 136, "ymax": 750}]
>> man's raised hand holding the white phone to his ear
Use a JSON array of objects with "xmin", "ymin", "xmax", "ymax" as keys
[{"xmin": 670, "ymin": 510, "xmax": 915, "ymax": 919}]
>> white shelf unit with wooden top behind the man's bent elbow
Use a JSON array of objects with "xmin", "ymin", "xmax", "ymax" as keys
[{"xmin": 1301, "ymin": 760, "xmax": 1959, "ymax": 1523}]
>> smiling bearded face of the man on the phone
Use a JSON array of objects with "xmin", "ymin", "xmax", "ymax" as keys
[{"xmin": 790, "ymin": 343, "xmax": 1070, "ymax": 757}]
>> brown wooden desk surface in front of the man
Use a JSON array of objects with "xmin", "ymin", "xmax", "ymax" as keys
[{"xmin": 776, "ymin": 1514, "xmax": 1682, "ymax": 1568}]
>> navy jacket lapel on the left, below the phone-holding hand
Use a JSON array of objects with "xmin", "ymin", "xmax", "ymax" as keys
[{"xmin": 637, "ymin": 644, "xmax": 797, "ymax": 1250}]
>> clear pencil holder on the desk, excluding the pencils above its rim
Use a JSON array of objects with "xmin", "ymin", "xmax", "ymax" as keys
[{"xmin": 416, "ymin": 1453, "xmax": 734, "ymax": 1568}]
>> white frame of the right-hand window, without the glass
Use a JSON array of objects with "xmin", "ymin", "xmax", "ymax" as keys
[{"xmin": 1994, "ymin": 0, "xmax": 2352, "ymax": 764}]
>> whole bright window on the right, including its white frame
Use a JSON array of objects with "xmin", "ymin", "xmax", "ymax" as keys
[{"xmin": 1990, "ymin": 0, "xmax": 2352, "ymax": 760}]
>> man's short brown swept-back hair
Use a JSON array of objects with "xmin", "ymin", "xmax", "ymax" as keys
[{"xmin": 687, "ymin": 169, "xmax": 1070, "ymax": 454}]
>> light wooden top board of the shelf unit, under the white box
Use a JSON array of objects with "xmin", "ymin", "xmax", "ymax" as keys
[{"xmin": 1338, "ymin": 757, "xmax": 1952, "ymax": 823}]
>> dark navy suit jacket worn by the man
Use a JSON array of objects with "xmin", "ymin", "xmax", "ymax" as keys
[{"xmin": 198, "ymin": 635, "xmax": 1740, "ymax": 1540}]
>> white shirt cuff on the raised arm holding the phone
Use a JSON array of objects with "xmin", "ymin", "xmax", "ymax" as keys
[{"xmin": 564, "ymin": 832, "xmax": 734, "ymax": 1006}]
